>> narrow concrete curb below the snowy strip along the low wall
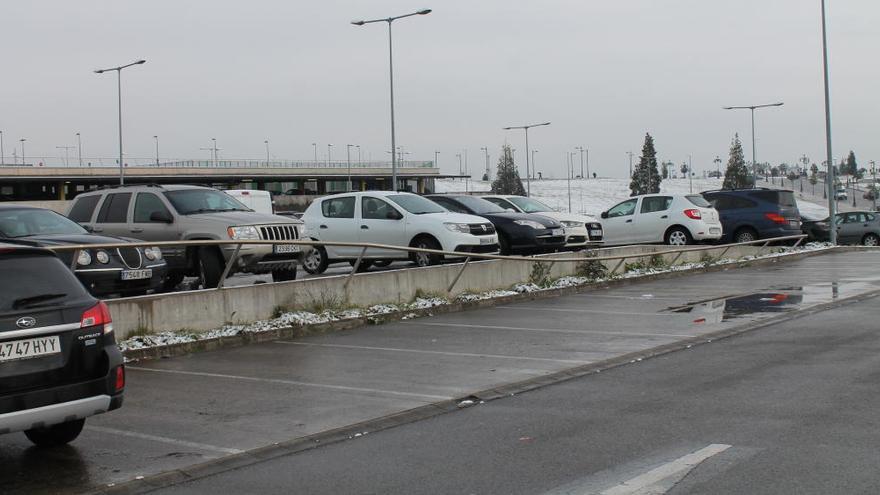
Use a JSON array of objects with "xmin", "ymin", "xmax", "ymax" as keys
[{"xmin": 123, "ymin": 248, "xmax": 836, "ymax": 361}]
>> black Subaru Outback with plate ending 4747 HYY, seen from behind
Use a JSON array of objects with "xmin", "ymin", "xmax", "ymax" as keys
[{"xmin": 0, "ymin": 242, "xmax": 125, "ymax": 446}]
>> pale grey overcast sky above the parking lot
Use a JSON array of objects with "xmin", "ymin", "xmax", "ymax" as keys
[{"xmin": 0, "ymin": 0, "xmax": 880, "ymax": 176}]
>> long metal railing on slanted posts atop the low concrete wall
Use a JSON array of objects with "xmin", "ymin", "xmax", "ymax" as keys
[{"xmin": 46, "ymin": 234, "xmax": 807, "ymax": 292}]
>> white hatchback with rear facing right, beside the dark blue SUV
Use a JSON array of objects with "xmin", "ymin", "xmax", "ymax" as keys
[{"xmin": 602, "ymin": 194, "xmax": 723, "ymax": 246}]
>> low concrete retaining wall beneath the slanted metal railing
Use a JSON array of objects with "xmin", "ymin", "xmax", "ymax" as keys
[{"xmin": 107, "ymin": 246, "xmax": 769, "ymax": 338}]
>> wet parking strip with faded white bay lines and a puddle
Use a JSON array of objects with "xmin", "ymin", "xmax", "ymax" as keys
[{"xmin": 0, "ymin": 251, "xmax": 880, "ymax": 493}]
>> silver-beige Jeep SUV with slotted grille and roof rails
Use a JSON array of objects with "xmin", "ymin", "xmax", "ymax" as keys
[{"xmin": 67, "ymin": 185, "xmax": 303, "ymax": 289}]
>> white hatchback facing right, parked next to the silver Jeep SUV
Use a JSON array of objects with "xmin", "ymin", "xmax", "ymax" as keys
[{"xmin": 303, "ymin": 191, "xmax": 498, "ymax": 273}]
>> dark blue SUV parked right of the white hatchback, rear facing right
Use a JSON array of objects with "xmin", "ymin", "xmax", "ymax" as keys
[{"xmin": 702, "ymin": 188, "xmax": 801, "ymax": 242}]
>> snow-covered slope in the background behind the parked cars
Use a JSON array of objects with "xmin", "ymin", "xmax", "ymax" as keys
[{"xmin": 435, "ymin": 178, "xmax": 828, "ymax": 217}]
